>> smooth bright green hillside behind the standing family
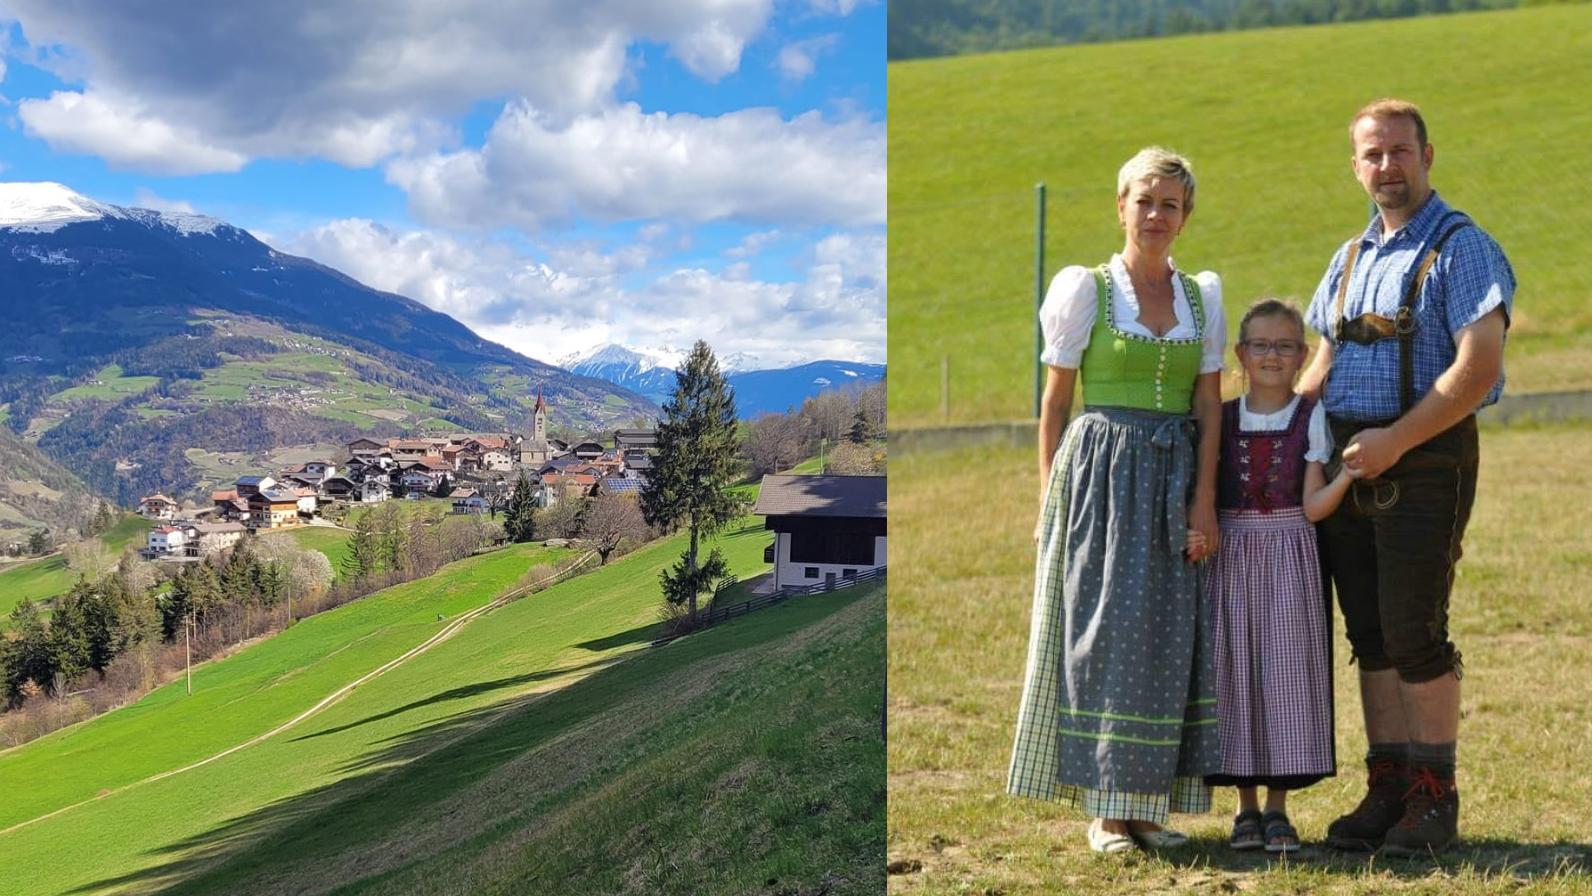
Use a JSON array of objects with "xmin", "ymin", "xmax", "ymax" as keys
[{"xmin": 890, "ymin": 5, "xmax": 1592, "ymax": 425}]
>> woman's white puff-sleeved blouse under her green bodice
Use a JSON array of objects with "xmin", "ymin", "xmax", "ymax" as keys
[{"xmin": 1040, "ymin": 255, "xmax": 1227, "ymax": 374}]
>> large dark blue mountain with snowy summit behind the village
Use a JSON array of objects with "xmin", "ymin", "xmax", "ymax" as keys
[{"xmin": 0, "ymin": 183, "xmax": 657, "ymax": 504}]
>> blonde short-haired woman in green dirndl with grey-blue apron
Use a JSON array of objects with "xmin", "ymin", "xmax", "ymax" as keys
[{"xmin": 1006, "ymin": 146, "xmax": 1226, "ymax": 851}]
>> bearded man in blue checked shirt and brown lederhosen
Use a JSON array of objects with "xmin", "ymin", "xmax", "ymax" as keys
[{"xmin": 1299, "ymin": 99, "xmax": 1514, "ymax": 856}]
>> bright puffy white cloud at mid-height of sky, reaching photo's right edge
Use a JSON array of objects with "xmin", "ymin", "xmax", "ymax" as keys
[{"xmin": 387, "ymin": 103, "xmax": 885, "ymax": 229}]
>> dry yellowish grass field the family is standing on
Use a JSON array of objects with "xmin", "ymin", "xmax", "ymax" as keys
[{"xmin": 890, "ymin": 425, "xmax": 1592, "ymax": 896}]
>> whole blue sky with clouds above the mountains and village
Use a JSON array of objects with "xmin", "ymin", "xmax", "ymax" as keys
[{"xmin": 0, "ymin": 0, "xmax": 885, "ymax": 366}]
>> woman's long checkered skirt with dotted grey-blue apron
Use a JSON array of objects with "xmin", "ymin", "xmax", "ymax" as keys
[{"xmin": 1006, "ymin": 407, "xmax": 1219, "ymax": 823}]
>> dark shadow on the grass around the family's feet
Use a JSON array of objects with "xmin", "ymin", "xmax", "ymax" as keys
[{"xmin": 1151, "ymin": 837, "xmax": 1592, "ymax": 882}]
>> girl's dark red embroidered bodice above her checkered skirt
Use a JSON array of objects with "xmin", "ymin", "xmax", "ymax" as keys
[{"xmin": 1216, "ymin": 398, "xmax": 1315, "ymax": 512}]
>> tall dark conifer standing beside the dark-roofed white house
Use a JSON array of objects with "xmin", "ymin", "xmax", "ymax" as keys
[{"xmin": 642, "ymin": 341, "xmax": 740, "ymax": 625}]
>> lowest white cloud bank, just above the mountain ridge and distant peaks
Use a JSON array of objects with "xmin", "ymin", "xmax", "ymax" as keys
[{"xmin": 280, "ymin": 220, "xmax": 885, "ymax": 366}]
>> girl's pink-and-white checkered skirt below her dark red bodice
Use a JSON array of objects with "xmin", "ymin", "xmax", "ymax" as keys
[{"xmin": 1205, "ymin": 508, "xmax": 1336, "ymax": 778}]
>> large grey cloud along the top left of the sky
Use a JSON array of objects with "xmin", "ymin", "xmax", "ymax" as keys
[{"xmin": 6, "ymin": 0, "xmax": 772, "ymax": 172}]
